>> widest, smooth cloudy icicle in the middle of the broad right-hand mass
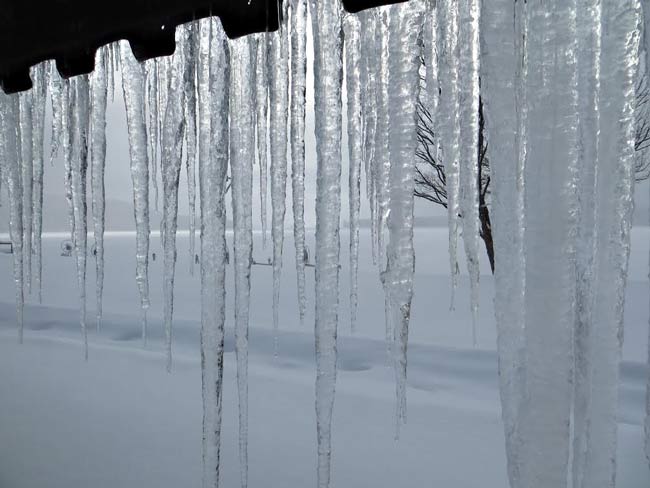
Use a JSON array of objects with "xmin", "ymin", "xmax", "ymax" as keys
[{"xmin": 519, "ymin": 0, "xmax": 578, "ymax": 487}]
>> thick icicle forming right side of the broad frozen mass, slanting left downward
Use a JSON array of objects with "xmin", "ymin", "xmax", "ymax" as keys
[{"xmin": 576, "ymin": 0, "xmax": 639, "ymax": 488}]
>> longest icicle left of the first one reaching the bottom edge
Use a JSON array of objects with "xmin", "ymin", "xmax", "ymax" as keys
[{"xmin": 161, "ymin": 27, "xmax": 191, "ymax": 372}]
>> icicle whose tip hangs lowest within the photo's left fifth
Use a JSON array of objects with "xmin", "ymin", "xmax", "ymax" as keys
[{"xmin": 70, "ymin": 75, "xmax": 90, "ymax": 360}]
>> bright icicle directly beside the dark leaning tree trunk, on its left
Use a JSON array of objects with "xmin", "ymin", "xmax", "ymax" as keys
[{"xmin": 458, "ymin": 0, "xmax": 481, "ymax": 346}]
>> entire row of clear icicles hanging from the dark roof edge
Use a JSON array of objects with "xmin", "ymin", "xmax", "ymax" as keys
[{"xmin": 0, "ymin": 0, "xmax": 650, "ymax": 488}]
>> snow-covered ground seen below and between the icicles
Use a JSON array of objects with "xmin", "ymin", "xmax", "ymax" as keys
[{"xmin": 0, "ymin": 228, "xmax": 650, "ymax": 488}]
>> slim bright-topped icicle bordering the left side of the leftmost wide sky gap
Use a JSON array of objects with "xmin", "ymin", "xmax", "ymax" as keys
[{"xmin": 90, "ymin": 49, "xmax": 108, "ymax": 330}]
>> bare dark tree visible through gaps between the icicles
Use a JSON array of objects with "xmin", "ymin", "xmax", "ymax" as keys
[{"xmin": 415, "ymin": 76, "xmax": 650, "ymax": 273}]
